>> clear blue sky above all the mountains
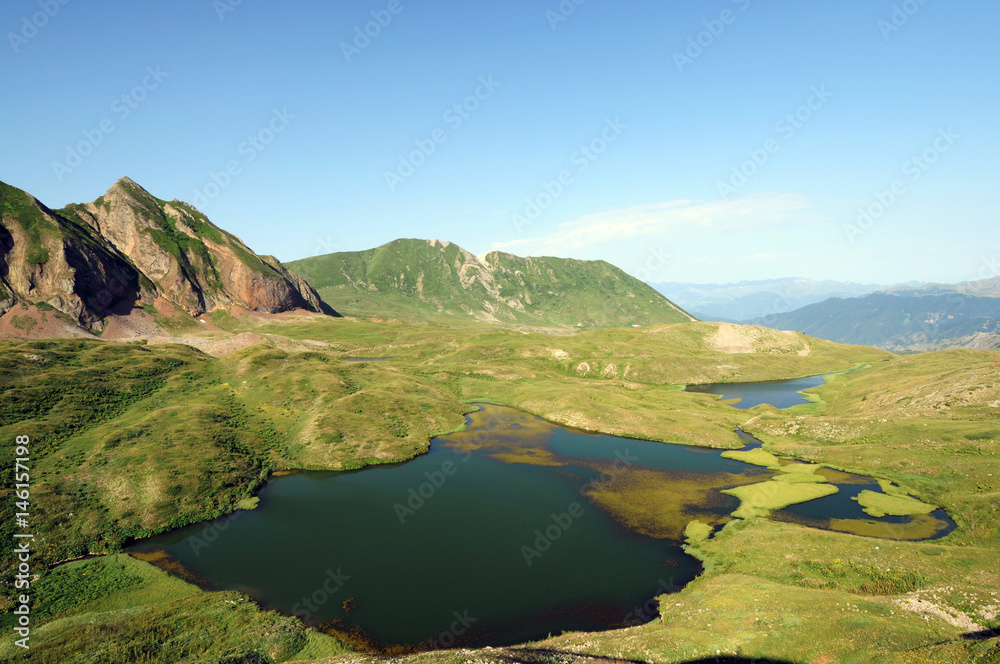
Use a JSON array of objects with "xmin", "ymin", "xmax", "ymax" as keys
[{"xmin": 0, "ymin": 0, "xmax": 1000, "ymax": 283}]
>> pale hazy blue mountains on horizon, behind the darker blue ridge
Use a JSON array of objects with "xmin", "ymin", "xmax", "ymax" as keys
[{"xmin": 651, "ymin": 278, "xmax": 885, "ymax": 322}]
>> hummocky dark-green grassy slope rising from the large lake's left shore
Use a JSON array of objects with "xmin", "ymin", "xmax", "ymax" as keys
[{"xmin": 0, "ymin": 341, "xmax": 467, "ymax": 570}]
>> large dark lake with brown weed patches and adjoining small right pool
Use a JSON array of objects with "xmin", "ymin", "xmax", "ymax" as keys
[{"xmin": 129, "ymin": 404, "xmax": 953, "ymax": 653}]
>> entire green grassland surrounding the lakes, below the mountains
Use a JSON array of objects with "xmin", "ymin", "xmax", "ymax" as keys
[{"xmin": 0, "ymin": 318, "xmax": 1000, "ymax": 664}]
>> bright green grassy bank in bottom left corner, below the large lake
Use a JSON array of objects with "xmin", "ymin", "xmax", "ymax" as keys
[{"xmin": 0, "ymin": 554, "xmax": 344, "ymax": 664}]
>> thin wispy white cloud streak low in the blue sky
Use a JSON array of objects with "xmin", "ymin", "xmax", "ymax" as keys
[{"xmin": 492, "ymin": 193, "xmax": 809, "ymax": 256}]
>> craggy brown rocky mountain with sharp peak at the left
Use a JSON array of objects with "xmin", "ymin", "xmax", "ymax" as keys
[{"xmin": 0, "ymin": 178, "xmax": 336, "ymax": 330}]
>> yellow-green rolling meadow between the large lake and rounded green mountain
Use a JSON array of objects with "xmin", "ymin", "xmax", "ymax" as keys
[{"xmin": 252, "ymin": 321, "xmax": 889, "ymax": 447}]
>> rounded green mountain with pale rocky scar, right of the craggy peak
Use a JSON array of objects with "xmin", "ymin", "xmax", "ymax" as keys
[{"xmin": 288, "ymin": 239, "xmax": 692, "ymax": 329}]
